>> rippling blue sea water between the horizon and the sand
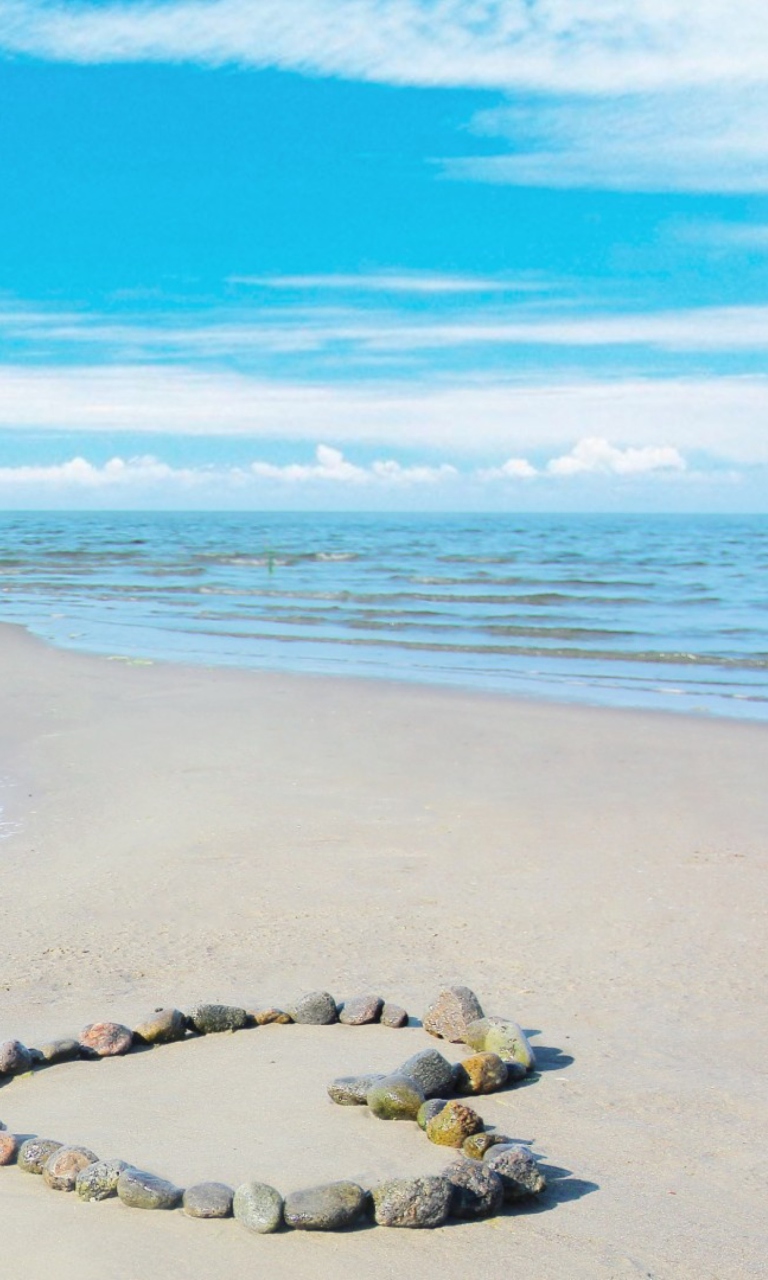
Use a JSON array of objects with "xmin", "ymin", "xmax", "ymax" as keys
[{"xmin": 0, "ymin": 512, "xmax": 768, "ymax": 719}]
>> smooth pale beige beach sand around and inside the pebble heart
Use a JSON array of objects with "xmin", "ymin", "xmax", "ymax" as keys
[{"xmin": 0, "ymin": 616, "xmax": 768, "ymax": 1280}]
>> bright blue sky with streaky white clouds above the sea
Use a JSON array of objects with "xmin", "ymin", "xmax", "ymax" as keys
[{"xmin": 0, "ymin": 0, "xmax": 768, "ymax": 511}]
